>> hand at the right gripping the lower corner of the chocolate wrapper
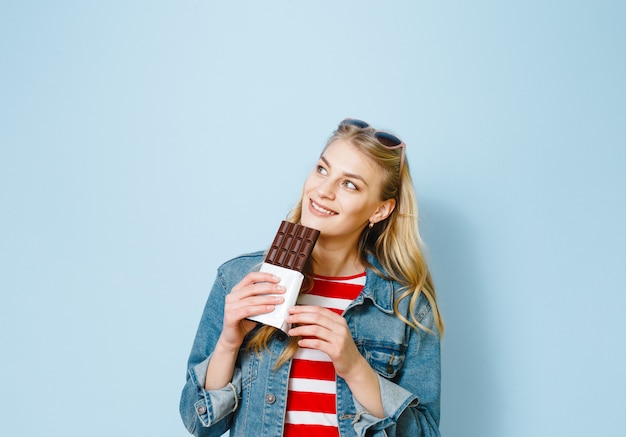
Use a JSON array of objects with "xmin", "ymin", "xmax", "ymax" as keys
[{"xmin": 287, "ymin": 305, "xmax": 365, "ymax": 379}]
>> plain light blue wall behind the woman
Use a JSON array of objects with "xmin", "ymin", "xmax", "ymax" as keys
[{"xmin": 0, "ymin": 0, "xmax": 626, "ymax": 437}]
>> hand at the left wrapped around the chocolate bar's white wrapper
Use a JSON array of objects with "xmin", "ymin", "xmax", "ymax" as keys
[{"xmin": 218, "ymin": 272, "xmax": 285, "ymax": 351}]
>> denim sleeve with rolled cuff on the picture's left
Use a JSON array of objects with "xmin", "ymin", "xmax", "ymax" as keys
[{"xmin": 179, "ymin": 270, "xmax": 241, "ymax": 437}]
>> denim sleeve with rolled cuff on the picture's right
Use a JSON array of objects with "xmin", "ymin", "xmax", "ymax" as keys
[{"xmin": 353, "ymin": 304, "xmax": 441, "ymax": 437}]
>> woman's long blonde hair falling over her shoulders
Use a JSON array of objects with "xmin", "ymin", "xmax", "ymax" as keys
[{"xmin": 247, "ymin": 124, "xmax": 444, "ymax": 368}]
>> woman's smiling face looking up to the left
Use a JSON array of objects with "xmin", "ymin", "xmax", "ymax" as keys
[{"xmin": 301, "ymin": 140, "xmax": 395, "ymax": 244}]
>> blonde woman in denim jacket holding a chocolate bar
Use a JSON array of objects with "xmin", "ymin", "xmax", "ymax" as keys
[{"xmin": 180, "ymin": 119, "xmax": 443, "ymax": 437}]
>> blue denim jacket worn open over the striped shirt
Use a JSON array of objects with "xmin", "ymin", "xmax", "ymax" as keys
[{"xmin": 180, "ymin": 252, "xmax": 441, "ymax": 437}]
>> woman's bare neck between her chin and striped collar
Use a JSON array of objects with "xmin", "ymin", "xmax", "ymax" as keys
[{"xmin": 313, "ymin": 241, "xmax": 365, "ymax": 277}]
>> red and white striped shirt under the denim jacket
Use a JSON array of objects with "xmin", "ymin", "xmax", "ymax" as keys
[{"xmin": 283, "ymin": 272, "xmax": 365, "ymax": 437}]
